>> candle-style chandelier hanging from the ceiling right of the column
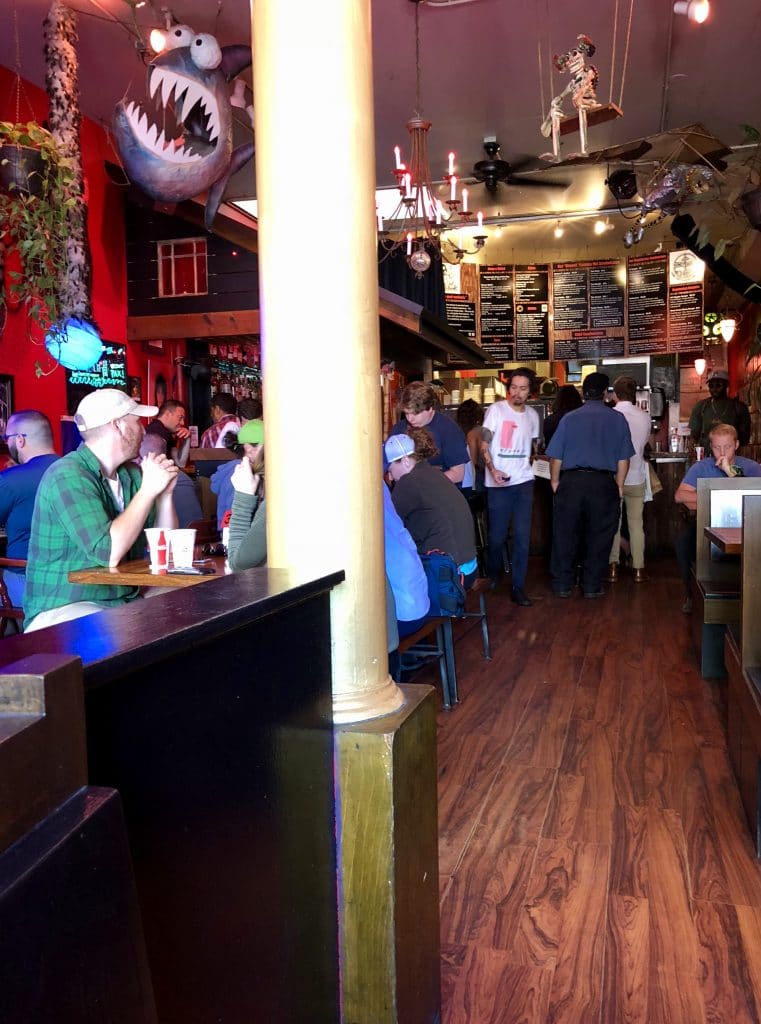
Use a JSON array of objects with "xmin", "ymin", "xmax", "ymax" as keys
[{"xmin": 378, "ymin": 0, "xmax": 487, "ymax": 278}]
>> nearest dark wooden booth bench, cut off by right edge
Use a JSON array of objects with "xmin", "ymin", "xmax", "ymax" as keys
[{"xmin": 724, "ymin": 495, "xmax": 761, "ymax": 857}]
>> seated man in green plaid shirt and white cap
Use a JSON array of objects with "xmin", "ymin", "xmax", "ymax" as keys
[{"xmin": 25, "ymin": 388, "xmax": 178, "ymax": 632}]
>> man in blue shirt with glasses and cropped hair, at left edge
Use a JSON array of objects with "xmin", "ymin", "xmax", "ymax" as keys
[{"xmin": 0, "ymin": 409, "xmax": 58, "ymax": 607}]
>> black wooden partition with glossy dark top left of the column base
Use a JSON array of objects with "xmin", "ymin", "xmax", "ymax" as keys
[{"xmin": 0, "ymin": 568, "xmax": 343, "ymax": 1024}]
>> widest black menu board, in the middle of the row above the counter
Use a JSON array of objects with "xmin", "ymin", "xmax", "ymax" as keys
[{"xmin": 552, "ymin": 259, "xmax": 626, "ymax": 359}]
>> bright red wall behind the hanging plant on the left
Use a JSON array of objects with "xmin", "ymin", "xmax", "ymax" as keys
[{"xmin": 0, "ymin": 68, "xmax": 173, "ymax": 441}]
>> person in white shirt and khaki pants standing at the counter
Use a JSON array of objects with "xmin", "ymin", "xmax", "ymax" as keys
[{"xmin": 607, "ymin": 377, "xmax": 651, "ymax": 583}]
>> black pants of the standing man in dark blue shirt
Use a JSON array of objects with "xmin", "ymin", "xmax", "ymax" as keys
[{"xmin": 552, "ymin": 469, "xmax": 621, "ymax": 594}]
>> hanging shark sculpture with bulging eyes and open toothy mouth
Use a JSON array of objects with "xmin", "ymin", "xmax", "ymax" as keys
[{"xmin": 114, "ymin": 25, "xmax": 254, "ymax": 230}]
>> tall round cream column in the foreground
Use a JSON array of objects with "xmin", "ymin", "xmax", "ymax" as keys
[{"xmin": 252, "ymin": 0, "xmax": 404, "ymax": 722}]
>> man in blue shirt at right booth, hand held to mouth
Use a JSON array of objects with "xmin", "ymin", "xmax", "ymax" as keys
[{"xmin": 674, "ymin": 423, "xmax": 761, "ymax": 615}]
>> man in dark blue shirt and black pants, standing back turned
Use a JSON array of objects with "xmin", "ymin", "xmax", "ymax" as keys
[{"xmin": 546, "ymin": 373, "xmax": 634, "ymax": 598}]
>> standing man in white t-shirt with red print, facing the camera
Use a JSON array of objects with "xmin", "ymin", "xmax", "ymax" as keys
[{"xmin": 481, "ymin": 367, "xmax": 539, "ymax": 607}]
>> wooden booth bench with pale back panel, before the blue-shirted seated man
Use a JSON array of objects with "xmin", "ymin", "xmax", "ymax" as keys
[{"xmin": 691, "ymin": 477, "xmax": 761, "ymax": 679}]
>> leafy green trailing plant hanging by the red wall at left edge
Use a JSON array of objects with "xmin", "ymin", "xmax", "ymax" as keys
[{"xmin": 0, "ymin": 121, "xmax": 76, "ymax": 330}]
